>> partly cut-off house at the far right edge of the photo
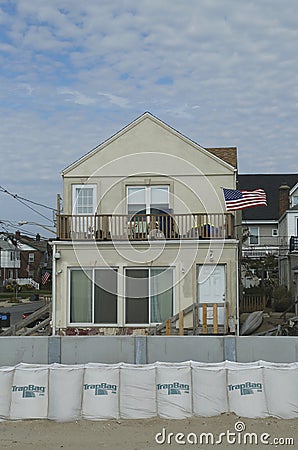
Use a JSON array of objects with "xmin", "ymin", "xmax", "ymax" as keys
[{"xmin": 279, "ymin": 178, "xmax": 298, "ymax": 314}]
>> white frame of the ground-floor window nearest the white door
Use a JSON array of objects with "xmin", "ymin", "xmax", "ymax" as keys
[{"xmin": 123, "ymin": 266, "xmax": 176, "ymax": 328}]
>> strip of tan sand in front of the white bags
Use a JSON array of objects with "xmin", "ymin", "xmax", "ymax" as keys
[{"xmin": 0, "ymin": 414, "xmax": 298, "ymax": 450}]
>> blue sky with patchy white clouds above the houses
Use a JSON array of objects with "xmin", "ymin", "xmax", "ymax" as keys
[{"xmin": 0, "ymin": 0, "xmax": 298, "ymax": 234}]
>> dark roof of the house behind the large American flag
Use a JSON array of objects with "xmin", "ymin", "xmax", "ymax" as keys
[{"xmin": 238, "ymin": 173, "xmax": 298, "ymax": 221}]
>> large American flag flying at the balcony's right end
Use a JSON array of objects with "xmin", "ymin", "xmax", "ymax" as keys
[{"xmin": 223, "ymin": 189, "xmax": 267, "ymax": 211}]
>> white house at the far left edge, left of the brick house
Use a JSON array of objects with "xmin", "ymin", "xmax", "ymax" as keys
[{"xmin": 0, "ymin": 233, "xmax": 21, "ymax": 287}]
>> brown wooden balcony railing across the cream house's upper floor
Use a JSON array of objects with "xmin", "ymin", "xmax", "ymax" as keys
[{"xmin": 57, "ymin": 213, "xmax": 234, "ymax": 241}]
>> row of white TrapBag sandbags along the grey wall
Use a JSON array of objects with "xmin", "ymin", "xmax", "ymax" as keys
[{"xmin": 0, "ymin": 361, "xmax": 298, "ymax": 422}]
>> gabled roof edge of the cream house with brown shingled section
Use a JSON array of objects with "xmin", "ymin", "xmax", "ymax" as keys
[{"xmin": 62, "ymin": 111, "xmax": 237, "ymax": 176}]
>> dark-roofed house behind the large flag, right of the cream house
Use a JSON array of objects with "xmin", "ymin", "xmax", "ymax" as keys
[{"xmin": 238, "ymin": 173, "xmax": 298, "ymax": 294}]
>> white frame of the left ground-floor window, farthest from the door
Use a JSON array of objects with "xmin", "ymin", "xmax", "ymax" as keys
[{"xmin": 67, "ymin": 267, "xmax": 119, "ymax": 328}]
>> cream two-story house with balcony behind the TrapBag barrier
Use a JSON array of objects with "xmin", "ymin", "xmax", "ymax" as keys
[{"xmin": 53, "ymin": 113, "xmax": 238, "ymax": 334}]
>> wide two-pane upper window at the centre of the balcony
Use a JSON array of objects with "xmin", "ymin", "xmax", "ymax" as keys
[{"xmin": 127, "ymin": 186, "xmax": 169, "ymax": 214}]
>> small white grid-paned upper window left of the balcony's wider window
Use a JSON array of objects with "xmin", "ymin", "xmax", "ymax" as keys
[{"xmin": 72, "ymin": 184, "xmax": 96, "ymax": 214}]
